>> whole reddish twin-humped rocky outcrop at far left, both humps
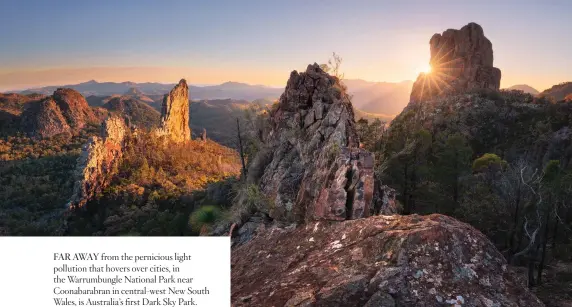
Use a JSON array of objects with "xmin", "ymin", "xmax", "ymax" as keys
[{"xmin": 21, "ymin": 88, "xmax": 97, "ymax": 138}]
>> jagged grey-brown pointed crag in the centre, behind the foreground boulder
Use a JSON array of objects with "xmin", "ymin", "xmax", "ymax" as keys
[{"xmin": 248, "ymin": 64, "xmax": 374, "ymax": 222}]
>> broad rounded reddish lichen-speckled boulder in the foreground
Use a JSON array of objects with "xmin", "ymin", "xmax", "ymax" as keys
[{"xmin": 231, "ymin": 214, "xmax": 544, "ymax": 307}]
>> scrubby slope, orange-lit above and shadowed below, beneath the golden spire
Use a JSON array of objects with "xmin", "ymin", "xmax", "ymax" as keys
[{"xmin": 69, "ymin": 134, "xmax": 240, "ymax": 235}]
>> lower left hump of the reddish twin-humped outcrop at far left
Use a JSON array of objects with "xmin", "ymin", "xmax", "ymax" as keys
[{"xmin": 20, "ymin": 97, "xmax": 72, "ymax": 138}]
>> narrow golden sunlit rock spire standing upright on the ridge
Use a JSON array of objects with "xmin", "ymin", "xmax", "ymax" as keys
[{"xmin": 157, "ymin": 79, "xmax": 191, "ymax": 143}]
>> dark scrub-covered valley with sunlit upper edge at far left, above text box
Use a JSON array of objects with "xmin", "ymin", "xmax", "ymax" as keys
[{"xmin": 0, "ymin": 126, "xmax": 98, "ymax": 235}]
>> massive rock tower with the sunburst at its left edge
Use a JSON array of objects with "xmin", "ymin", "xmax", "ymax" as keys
[{"xmin": 411, "ymin": 23, "xmax": 501, "ymax": 101}]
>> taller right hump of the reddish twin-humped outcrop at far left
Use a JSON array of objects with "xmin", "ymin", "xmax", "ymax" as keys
[{"xmin": 52, "ymin": 88, "xmax": 96, "ymax": 129}]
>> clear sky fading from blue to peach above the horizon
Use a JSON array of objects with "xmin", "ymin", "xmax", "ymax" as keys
[{"xmin": 0, "ymin": 0, "xmax": 572, "ymax": 90}]
